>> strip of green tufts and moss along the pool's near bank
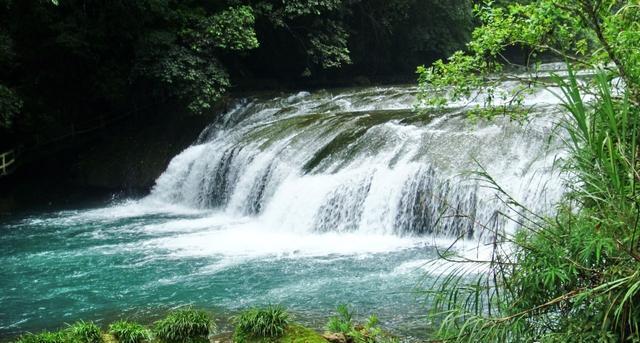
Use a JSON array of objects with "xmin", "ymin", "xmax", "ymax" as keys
[{"xmin": 0, "ymin": 305, "xmax": 409, "ymax": 343}]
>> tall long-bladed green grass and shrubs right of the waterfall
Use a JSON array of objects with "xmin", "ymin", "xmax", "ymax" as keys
[{"xmin": 428, "ymin": 66, "xmax": 640, "ymax": 342}]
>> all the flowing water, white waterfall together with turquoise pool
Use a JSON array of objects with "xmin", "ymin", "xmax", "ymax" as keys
[{"xmin": 0, "ymin": 76, "xmax": 563, "ymax": 336}]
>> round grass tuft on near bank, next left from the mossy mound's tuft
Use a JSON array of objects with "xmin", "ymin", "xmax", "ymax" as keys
[{"xmin": 154, "ymin": 308, "xmax": 215, "ymax": 342}]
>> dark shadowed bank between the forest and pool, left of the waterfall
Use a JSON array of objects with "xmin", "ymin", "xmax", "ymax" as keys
[{"xmin": 0, "ymin": 104, "xmax": 226, "ymax": 212}]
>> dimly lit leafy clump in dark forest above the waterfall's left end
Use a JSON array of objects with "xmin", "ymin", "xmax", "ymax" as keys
[{"xmin": 133, "ymin": 6, "xmax": 258, "ymax": 113}]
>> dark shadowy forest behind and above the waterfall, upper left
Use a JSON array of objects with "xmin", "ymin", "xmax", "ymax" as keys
[{"xmin": 0, "ymin": 0, "xmax": 473, "ymax": 154}]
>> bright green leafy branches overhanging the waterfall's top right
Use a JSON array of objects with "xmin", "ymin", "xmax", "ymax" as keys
[{"xmin": 417, "ymin": 0, "xmax": 640, "ymax": 117}]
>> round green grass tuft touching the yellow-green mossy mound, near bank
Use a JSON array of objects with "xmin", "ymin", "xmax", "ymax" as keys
[{"xmin": 233, "ymin": 306, "xmax": 289, "ymax": 342}]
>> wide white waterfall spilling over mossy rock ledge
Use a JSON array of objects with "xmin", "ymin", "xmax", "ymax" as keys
[{"xmin": 148, "ymin": 86, "xmax": 563, "ymax": 239}]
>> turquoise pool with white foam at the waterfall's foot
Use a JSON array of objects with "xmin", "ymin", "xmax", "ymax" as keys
[{"xmin": 0, "ymin": 202, "xmax": 440, "ymax": 338}]
